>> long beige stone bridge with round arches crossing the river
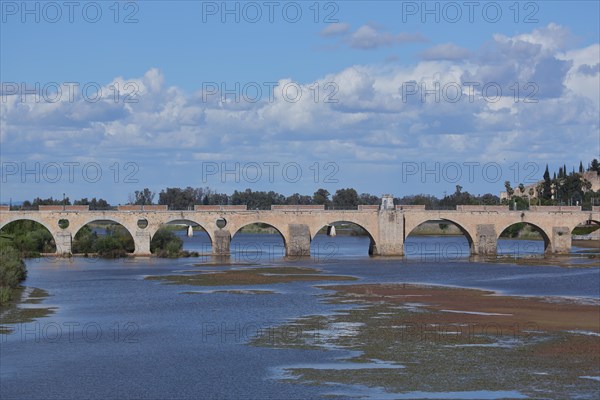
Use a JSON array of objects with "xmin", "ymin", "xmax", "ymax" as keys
[{"xmin": 0, "ymin": 204, "xmax": 600, "ymax": 256}]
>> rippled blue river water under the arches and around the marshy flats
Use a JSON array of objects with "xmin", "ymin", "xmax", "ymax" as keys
[{"xmin": 0, "ymin": 234, "xmax": 600, "ymax": 399}]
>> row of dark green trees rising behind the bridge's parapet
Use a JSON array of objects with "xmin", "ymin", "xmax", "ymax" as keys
[{"xmin": 13, "ymin": 159, "xmax": 600, "ymax": 210}]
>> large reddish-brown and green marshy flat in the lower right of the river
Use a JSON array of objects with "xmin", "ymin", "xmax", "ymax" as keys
[{"xmin": 252, "ymin": 284, "xmax": 600, "ymax": 399}]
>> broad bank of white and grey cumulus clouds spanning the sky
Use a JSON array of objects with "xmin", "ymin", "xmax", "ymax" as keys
[{"xmin": 0, "ymin": 25, "xmax": 600, "ymax": 194}]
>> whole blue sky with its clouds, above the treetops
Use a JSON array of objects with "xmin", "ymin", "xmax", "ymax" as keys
[{"xmin": 0, "ymin": 1, "xmax": 600, "ymax": 204}]
